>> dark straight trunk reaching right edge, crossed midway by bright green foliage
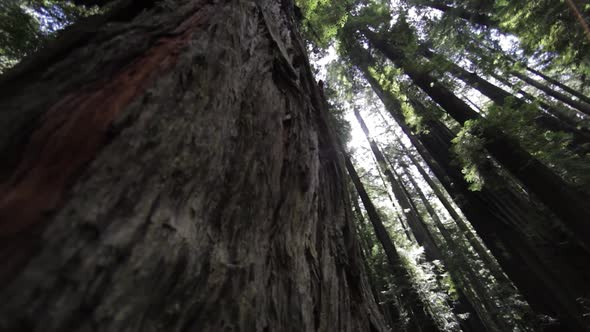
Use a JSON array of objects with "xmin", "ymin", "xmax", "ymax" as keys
[{"xmin": 362, "ymin": 29, "xmax": 590, "ymax": 254}]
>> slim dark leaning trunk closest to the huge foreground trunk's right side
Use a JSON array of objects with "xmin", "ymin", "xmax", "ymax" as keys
[{"xmin": 345, "ymin": 157, "xmax": 439, "ymax": 332}]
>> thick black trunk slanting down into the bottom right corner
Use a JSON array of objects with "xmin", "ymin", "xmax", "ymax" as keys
[{"xmin": 354, "ymin": 49, "xmax": 590, "ymax": 332}]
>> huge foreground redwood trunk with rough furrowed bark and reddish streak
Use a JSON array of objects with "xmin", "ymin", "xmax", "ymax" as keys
[{"xmin": 0, "ymin": 0, "xmax": 385, "ymax": 331}]
